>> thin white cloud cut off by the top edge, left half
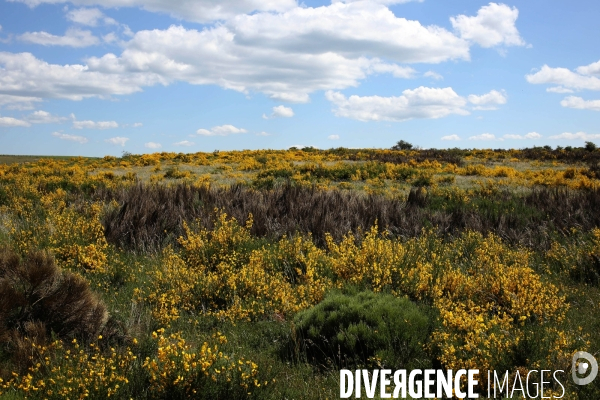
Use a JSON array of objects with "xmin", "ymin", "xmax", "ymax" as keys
[{"xmin": 9, "ymin": 0, "xmax": 296, "ymax": 22}]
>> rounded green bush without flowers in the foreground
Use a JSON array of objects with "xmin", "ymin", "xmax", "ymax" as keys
[{"xmin": 294, "ymin": 291, "xmax": 430, "ymax": 369}]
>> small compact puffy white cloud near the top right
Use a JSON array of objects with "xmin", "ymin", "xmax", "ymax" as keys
[{"xmin": 450, "ymin": 3, "xmax": 526, "ymax": 47}]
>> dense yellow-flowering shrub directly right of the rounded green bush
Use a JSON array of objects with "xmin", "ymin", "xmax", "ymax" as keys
[{"xmin": 433, "ymin": 234, "xmax": 570, "ymax": 370}]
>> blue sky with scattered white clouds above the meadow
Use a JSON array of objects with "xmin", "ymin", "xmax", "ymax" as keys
[{"xmin": 0, "ymin": 0, "xmax": 600, "ymax": 156}]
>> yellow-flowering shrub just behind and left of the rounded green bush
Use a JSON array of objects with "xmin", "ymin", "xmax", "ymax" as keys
[{"xmin": 147, "ymin": 213, "xmax": 331, "ymax": 325}]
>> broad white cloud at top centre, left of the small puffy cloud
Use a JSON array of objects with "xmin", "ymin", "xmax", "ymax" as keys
[{"xmin": 227, "ymin": 1, "xmax": 469, "ymax": 63}]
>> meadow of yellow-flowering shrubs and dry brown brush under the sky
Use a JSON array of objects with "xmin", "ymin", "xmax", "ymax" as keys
[{"xmin": 0, "ymin": 144, "xmax": 600, "ymax": 399}]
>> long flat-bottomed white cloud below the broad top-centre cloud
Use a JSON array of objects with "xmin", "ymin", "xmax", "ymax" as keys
[{"xmin": 325, "ymin": 86, "xmax": 469, "ymax": 121}]
